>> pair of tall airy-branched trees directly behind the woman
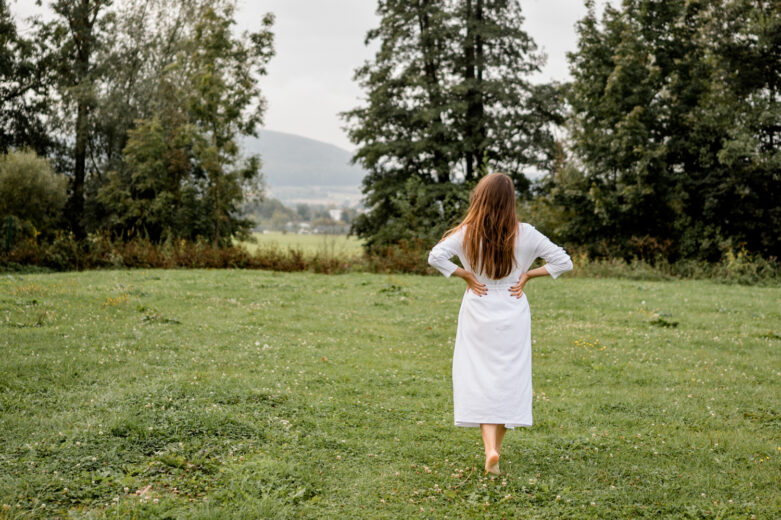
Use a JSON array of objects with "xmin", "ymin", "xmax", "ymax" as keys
[{"xmin": 343, "ymin": 0, "xmax": 561, "ymax": 249}]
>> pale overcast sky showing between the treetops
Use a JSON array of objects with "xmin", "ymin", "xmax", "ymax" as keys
[{"xmin": 11, "ymin": 0, "xmax": 615, "ymax": 150}]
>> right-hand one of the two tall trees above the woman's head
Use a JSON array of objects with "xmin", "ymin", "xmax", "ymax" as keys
[{"xmin": 453, "ymin": 0, "xmax": 564, "ymax": 191}]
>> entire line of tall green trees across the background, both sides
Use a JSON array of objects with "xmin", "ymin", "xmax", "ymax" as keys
[{"xmin": 0, "ymin": 0, "xmax": 781, "ymax": 261}]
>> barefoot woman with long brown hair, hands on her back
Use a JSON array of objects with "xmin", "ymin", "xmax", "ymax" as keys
[{"xmin": 428, "ymin": 173, "xmax": 572, "ymax": 474}]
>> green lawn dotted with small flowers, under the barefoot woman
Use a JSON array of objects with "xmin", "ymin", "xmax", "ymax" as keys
[{"xmin": 0, "ymin": 270, "xmax": 781, "ymax": 519}]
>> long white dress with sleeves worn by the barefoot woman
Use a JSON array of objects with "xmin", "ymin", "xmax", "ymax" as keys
[{"xmin": 428, "ymin": 223, "xmax": 572, "ymax": 428}]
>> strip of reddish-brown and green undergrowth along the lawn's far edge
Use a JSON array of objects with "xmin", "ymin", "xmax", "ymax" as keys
[{"xmin": 0, "ymin": 233, "xmax": 781, "ymax": 285}]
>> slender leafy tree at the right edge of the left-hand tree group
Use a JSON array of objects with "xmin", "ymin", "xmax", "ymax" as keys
[{"xmin": 183, "ymin": 2, "xmax": 274, "ymax": 246}]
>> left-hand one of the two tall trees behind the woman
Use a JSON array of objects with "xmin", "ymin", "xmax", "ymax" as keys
[{"xmin": 343, "ymin": 0, "xmax": 457, "ymax": 248}]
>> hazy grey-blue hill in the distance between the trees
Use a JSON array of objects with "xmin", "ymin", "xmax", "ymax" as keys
[{"xmin": 244, "ymin": 130, "xmax": 366, "ymax": 191}]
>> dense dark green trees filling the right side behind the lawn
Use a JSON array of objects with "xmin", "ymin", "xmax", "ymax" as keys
[{"xmin": 546, "ymin": 0, "xmax": 781, "ymax": 261}]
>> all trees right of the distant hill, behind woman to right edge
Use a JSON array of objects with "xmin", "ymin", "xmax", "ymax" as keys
[{"xmin": 344, "ymin": 0, "xmax": 781, "ymax": 261}]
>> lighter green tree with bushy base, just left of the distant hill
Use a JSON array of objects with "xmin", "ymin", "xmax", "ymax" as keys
[{"xmin": 96, "ymin": 2, "xmax": 273, "ymax": 246}]
